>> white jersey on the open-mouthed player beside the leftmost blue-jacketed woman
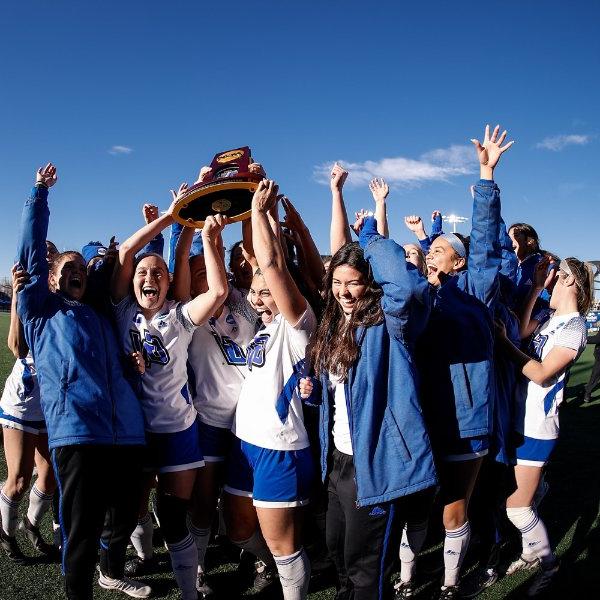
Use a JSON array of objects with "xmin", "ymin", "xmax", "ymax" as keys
[{"xmin": 114, "ymin": 296, "xmax": 196, "ymax": 433}]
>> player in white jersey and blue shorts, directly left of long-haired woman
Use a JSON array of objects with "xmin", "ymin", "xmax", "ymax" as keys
[{"xmin": 225, "ymin": 179, "xmax": 316, "ymax": 600}]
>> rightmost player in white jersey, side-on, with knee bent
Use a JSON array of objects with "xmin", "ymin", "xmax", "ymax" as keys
[{"xmin": 498, "ymin": 258, "xmax": 594, "ymax": 596}]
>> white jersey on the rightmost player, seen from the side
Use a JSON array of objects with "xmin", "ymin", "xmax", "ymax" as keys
[{"xmin": 516, "ymin": 313, "xmax": 587, "ymax": 440}]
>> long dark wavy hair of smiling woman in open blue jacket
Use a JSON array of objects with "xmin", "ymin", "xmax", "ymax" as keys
[{"xmin": 311, "ymin": 242, "xmax": 383, "ymax": 379}]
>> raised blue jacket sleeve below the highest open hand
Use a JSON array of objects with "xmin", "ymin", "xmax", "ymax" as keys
[{"xmin": 467, "ymin": 179, "xmax": 502, "ymax": 306}]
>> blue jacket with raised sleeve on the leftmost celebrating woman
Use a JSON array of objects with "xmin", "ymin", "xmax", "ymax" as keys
[{"xmin": 17, "ymin": 186, "xmax": 145, "ymax": 449}]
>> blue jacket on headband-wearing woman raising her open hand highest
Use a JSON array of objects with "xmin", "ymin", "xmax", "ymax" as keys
[{"xmin": 418, "ymin": 180, "xmax": 502, "ymax": 441}]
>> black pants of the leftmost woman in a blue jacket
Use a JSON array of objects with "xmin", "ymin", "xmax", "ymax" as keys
[{"xmin": 52, "ymin": 445, "xmax": 143, "ymax": 600}]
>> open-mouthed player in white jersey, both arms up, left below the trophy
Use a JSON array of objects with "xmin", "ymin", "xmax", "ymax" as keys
[{"xmin": 111, "ymin": 184, "xmax": 227, "ymax": 600}]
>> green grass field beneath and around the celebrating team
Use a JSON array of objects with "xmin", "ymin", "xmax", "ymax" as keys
[{"xmin": 0, "ymin": 313, "xmax": 600, "ymax": 600}]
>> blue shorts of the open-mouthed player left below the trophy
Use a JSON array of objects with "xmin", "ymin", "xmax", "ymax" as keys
[{"xmin": 144, "ymin": 419, "xmax": 204, "ymax": 473}]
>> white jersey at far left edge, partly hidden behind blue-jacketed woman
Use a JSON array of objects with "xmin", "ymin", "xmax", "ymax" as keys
[{"xmin": 0, "ymin": 354, "xmax": 44, "ymax": 421}]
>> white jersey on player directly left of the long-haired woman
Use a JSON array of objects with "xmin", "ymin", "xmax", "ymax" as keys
[{"xmin": 233, "ymin": 306, "xmax": 317, "ymax": 450}]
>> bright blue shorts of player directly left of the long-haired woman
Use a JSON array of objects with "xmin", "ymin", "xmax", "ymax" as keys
[{"xmin": 225, "ymin": 437, "xmax": 314, "ymax": 508}]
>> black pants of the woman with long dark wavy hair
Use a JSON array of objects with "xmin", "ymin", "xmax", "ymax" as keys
[{"xmin": 326, "ymin": 449, "xmax": 434, "ymax": 600}]
